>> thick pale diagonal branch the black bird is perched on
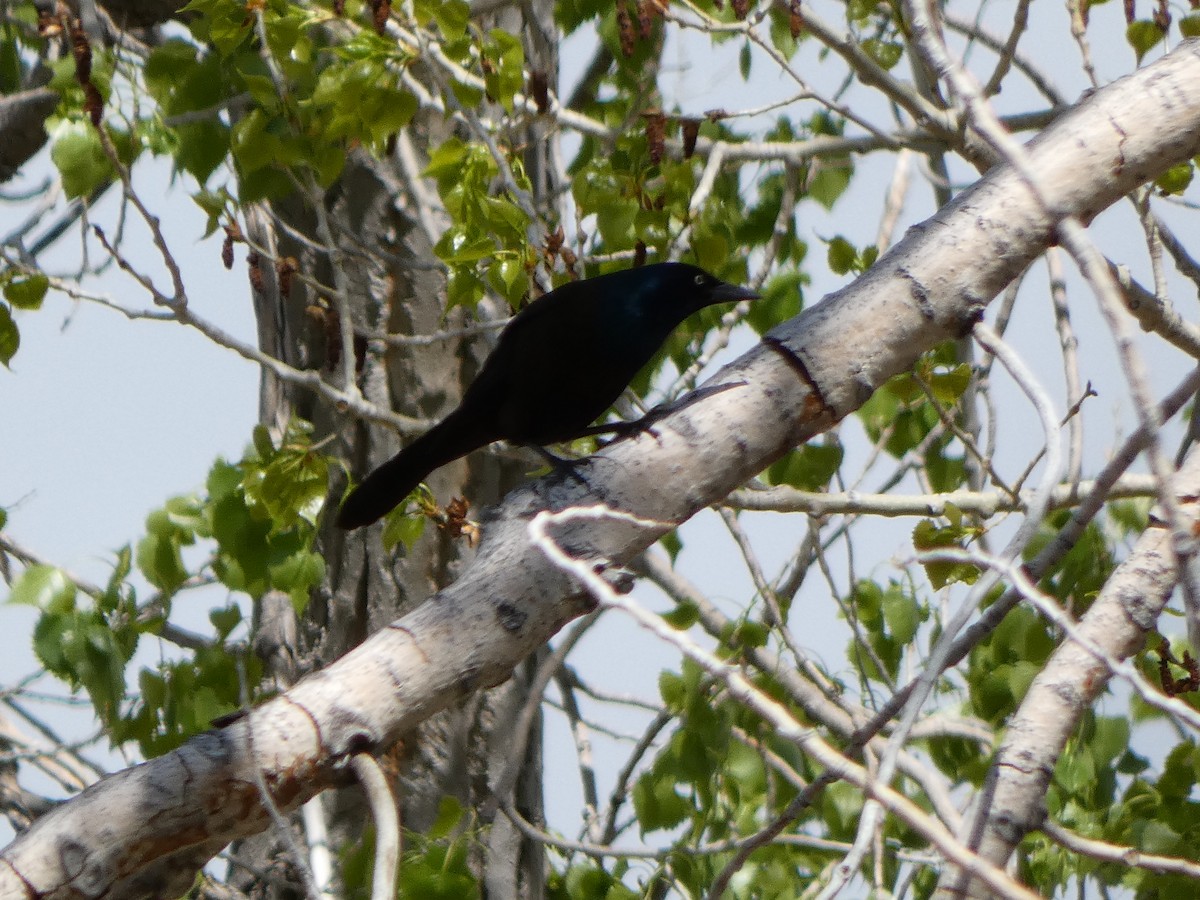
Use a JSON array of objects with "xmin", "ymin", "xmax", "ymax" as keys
[{"xmin": 7, "ymin": 42, "xmax": 1200, "ymax": 898}]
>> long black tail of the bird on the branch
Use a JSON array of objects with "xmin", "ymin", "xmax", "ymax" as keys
[{"xmin": 337, "ymin": 413, "xmax": 487, "ymax": 529}]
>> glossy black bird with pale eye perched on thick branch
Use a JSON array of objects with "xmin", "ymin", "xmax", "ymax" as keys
[{"xmin": 337, "ymin": 263, "xmax": 758, "ymax": 528}]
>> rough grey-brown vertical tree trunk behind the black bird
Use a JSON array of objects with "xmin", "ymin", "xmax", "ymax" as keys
[{"xmin": 236, "ymin": 2, "xmax": 557, "ymax": 898}]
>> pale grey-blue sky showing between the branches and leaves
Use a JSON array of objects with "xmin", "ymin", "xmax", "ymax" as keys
[{"xmin": 0, "ymin": 2, "xmax": 1195, "ymax": 868}]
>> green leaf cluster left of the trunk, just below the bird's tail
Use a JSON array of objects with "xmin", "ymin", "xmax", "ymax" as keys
[{"xmin": 8, "ymin": 424, "xmax": 328, "ymax": 756}]
